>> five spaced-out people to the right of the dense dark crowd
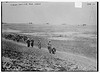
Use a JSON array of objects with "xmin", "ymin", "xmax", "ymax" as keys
[{"xmin": 26, "ymin": 39, "xmax": 56, "ymax": 54}]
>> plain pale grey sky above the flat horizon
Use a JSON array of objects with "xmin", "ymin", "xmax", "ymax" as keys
[{"xmin": 2, "ymin": 2, "xmax": 97, "ymax": 25}]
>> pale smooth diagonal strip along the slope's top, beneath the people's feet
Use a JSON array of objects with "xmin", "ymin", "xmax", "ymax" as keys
[{"xmin": 3, "ymin": 39, "xmax": 97, "ymax": 69}]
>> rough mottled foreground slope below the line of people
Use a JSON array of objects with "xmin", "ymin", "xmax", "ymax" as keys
[{"xmin": 2, "ymin": 40, "xmax": 96, "ymax": 71}]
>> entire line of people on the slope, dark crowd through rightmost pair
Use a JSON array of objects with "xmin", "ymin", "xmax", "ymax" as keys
[{"xmin": 3, "ymin": 34, "xmax": 56, "ymax": 54}]
